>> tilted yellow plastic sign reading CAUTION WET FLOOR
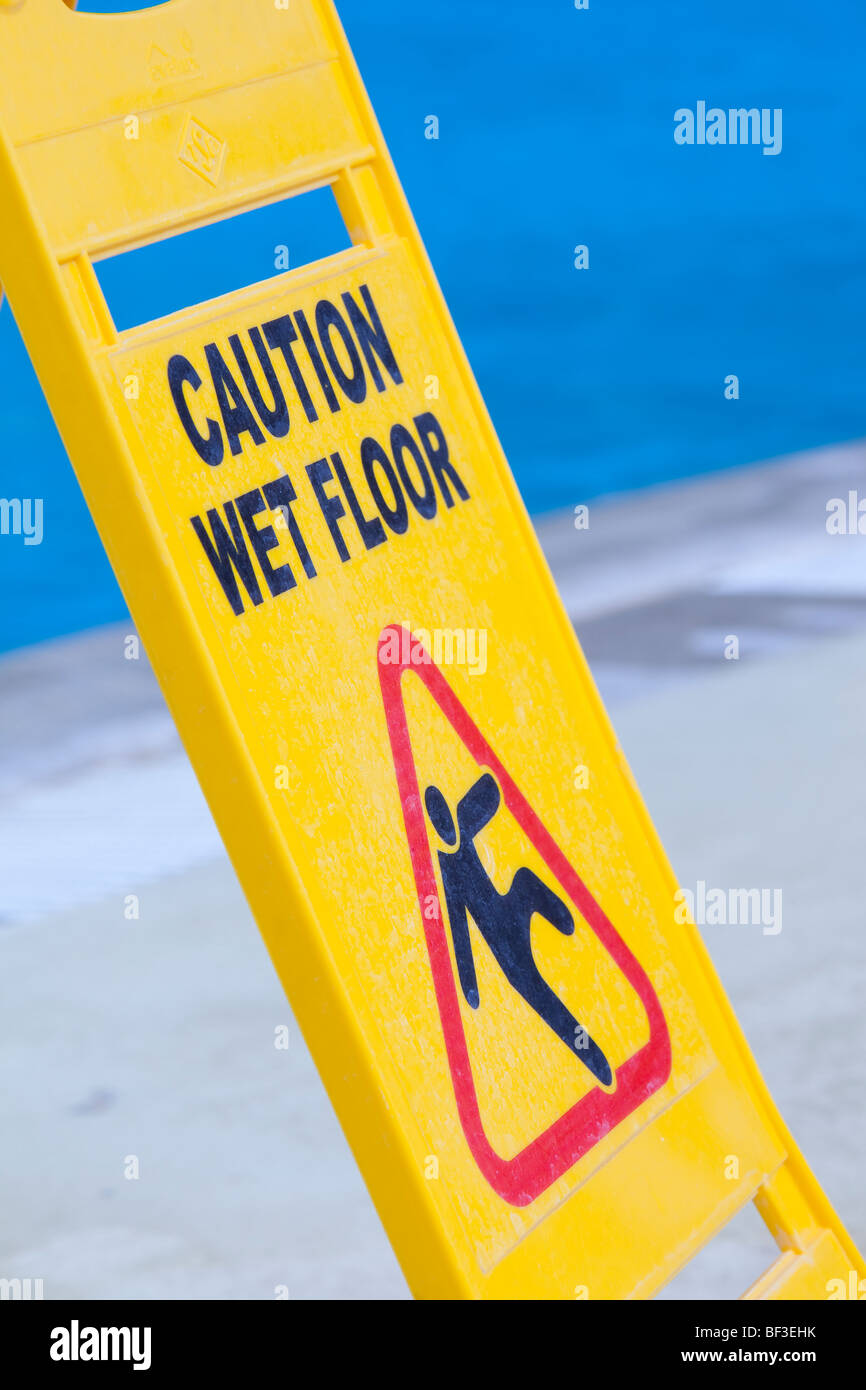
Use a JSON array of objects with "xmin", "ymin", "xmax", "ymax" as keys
[{"xmin": 0, "ymin": 0, "xmax": 863, "ymax": 1298}]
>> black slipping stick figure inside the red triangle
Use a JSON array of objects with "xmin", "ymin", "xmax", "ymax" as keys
[{"xmin": 424, "ymin": 773, "xmax": 613, "ymax": 1086}]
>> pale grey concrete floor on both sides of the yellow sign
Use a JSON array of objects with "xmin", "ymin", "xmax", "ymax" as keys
[{"xmin": 0, "ymin": 446, "xmax": 866, "ymax": 1298}]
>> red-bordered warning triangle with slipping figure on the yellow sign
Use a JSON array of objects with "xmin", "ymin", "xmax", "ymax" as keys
[{"xmin": 377, "ymin": 624, "xmax": 671, "ymax": 1207}]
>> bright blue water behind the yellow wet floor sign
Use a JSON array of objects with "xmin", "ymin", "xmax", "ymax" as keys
[{"xmin": 0, "ymin": 0, "xmax": 866, "ymax": 648}]
